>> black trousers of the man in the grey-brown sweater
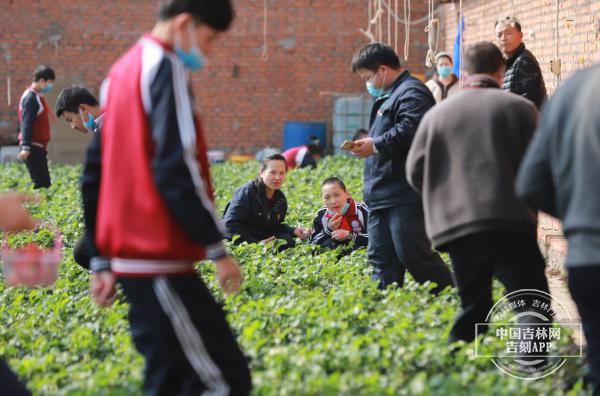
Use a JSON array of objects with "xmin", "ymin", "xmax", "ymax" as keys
[{"xmin": 444, "ymin": 231, "xmax": 548, "ymax": 342}]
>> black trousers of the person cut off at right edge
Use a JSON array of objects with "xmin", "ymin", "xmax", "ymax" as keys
[{"xmin": 568, "ymin": 265, "xmax": 600, "ymax": 396}]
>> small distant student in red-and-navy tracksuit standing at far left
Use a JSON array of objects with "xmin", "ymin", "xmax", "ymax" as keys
[{"xmin": 19, "ymin": 65, "xmax": 55, "ymax": 189}]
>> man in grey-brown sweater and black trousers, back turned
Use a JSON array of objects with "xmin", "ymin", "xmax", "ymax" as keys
[{"xmin": 406, "ymin": 42, "xmax": 548, "ymax": 342}]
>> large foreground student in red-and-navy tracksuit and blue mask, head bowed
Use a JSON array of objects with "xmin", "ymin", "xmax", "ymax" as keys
[{"xmin": 82, "ymin": 0, "xmax": 251, "ymax": 395}]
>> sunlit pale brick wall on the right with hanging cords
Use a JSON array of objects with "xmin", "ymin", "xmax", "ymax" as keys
[{"xmin": 437, "ymin": 0, "xmax": 600, "ymax": 272}]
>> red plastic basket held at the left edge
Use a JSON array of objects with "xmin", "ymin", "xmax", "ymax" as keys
[{"xmin": 2, "ymin": 227, "xmax": 62, "ymax": 287}]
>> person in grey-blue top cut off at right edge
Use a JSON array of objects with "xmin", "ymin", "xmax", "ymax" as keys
[{"xmin": 517, "ymin": 65, "xmax": 600, "ymax": 395}]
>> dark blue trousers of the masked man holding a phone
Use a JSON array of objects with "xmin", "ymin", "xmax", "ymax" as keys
[{"xmin": 367, "ymin": 204, "xmax": 453, "ymax": 293}]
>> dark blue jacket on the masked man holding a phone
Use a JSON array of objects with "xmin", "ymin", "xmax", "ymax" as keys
[{"xmin": 363, "ymin": 71, "xmax": 435, "ymax": 210}]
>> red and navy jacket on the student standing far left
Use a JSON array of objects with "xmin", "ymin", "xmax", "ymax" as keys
[{"xmin": 19, "ymin": 85, "xmax": 50, "ymax": 150}]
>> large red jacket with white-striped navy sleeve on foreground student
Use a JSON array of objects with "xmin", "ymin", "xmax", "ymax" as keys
[{"xmin": 83, "ymin": 36, "xmax": 226, "ymax": 276}]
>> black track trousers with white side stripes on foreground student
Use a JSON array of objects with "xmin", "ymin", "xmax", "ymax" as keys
[{"xmin": 119, "ymin": 275, "xmax": 251, "ymax": 396}]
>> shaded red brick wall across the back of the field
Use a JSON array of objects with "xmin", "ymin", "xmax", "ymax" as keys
[{"xmin": 0, "ymin": 0, "xmax": 427, "ymax": 155}]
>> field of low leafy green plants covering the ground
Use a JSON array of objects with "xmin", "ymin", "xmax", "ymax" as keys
[{"xmin": 0, "ymin": 158, "xmax": 583, "ymax": 395}]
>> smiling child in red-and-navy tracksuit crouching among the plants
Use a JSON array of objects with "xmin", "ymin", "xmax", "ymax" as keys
[{"xmin": 310, "ymin": 177, "xmax": 369, "ymax": 254}]
